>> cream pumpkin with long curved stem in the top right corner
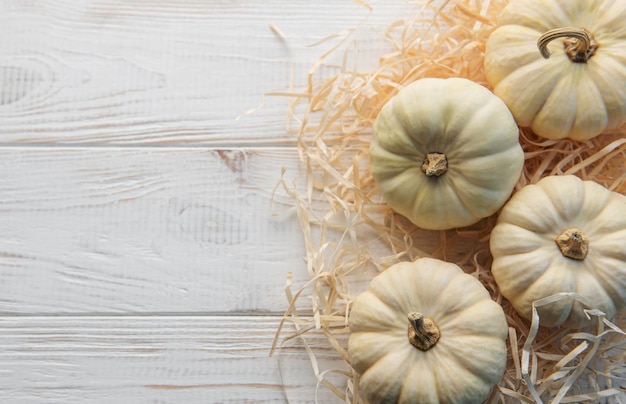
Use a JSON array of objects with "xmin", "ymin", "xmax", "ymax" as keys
[{"xmin": 485, "ymin": 0, "xmax": 626, "ymax": 140}]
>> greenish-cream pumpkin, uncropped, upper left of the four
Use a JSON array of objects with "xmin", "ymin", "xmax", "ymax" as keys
[{"xmin": 369, "ymin": 78, "xmax": 524, "ymax": 230}]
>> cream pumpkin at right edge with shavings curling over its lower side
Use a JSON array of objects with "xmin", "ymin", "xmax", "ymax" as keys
[{"xmin": 490, "ymin": 175, "xmax": 626, "ymax": 327}]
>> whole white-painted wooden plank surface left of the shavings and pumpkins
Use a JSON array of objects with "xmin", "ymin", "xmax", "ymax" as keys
[{"xmin": 0, "ymin": 0, "xmax": 418, "ymax": 403}]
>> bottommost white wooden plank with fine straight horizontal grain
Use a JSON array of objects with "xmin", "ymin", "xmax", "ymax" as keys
[{"xmin": 0, "ymin": 316, "xmax": 345, "ymax": 404}]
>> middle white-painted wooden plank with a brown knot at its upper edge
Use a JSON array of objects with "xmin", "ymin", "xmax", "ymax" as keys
[{"xmin": 0, "ymin": 147, "xmax": 308, "ymax": 314}]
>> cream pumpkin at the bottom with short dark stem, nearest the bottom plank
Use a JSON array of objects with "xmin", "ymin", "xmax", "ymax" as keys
[{"xmin": 348, "ymin": 258, "xmax": 508, "ymax": 404}]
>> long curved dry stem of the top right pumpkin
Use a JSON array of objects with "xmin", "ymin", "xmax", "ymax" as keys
[{"xmin": 537, "ymin": 27, "xmax": 598, "ymax": 63}]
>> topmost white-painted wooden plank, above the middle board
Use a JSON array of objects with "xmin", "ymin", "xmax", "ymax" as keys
[{"xmin": 0, "ymin": 0, "xmax": 418, "ymax": 145}]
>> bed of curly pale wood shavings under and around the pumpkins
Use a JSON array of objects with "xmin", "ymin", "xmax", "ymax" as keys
[{"xmin": 272, "ymin": 0, "xmax": 626, "ymax": 403}]
